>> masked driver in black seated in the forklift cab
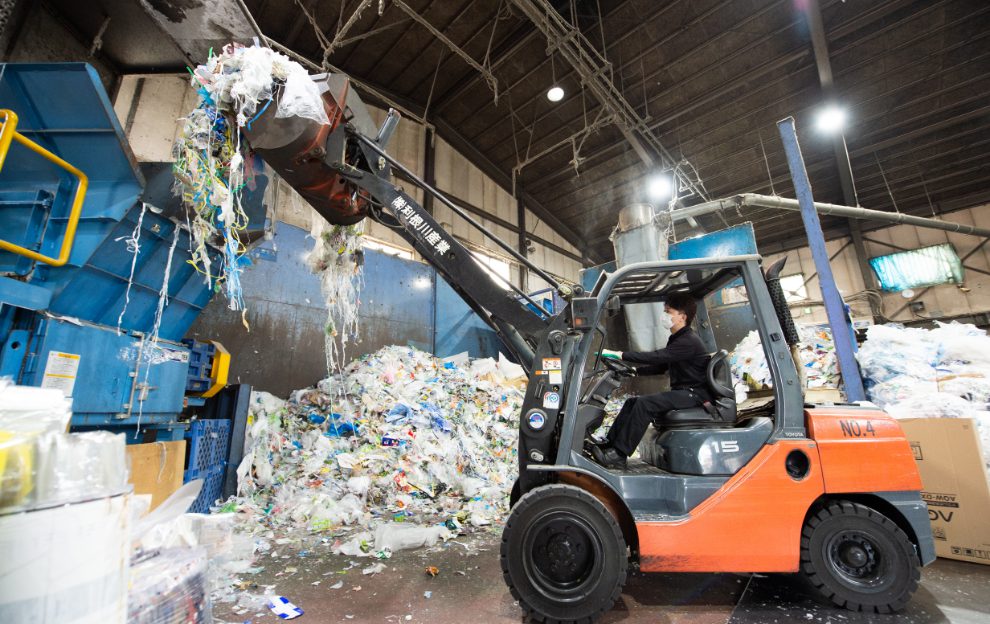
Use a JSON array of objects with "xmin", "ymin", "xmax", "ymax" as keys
[{"xmin": 593, "ymin": 293, "xmax": 712, "ymax": 468}]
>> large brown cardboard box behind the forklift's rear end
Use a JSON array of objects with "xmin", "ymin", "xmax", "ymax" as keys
[{"xmin": 900, "ymin": 418, "xmax": 990, "ymax": 565}]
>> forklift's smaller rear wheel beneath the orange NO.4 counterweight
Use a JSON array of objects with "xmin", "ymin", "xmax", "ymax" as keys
[{"xmin": 801, "ymin": 501, "xmax": 921, "ymax": 613}]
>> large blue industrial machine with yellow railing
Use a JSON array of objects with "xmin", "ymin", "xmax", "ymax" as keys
[{"xmin": 0, "ymin": 63, "xmax": 264, "ymax": 456}]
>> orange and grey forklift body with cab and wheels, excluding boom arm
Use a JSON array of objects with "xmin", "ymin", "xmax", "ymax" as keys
[{"xmin": 501, "ymin": 256, "xmax": 935, "ymax": 623}]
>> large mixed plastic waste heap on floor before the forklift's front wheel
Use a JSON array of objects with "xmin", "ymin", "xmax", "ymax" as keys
[{"xmin": 228, "ymin": 346, "xmax": 524, "ymax": 558}]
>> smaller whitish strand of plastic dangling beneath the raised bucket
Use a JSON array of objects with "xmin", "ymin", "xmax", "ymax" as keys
[{"xmin": 308, "ymin": 219, "xmax": 364, "ymax": 373}]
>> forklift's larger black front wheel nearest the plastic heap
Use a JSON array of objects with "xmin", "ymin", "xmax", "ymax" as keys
[{"xmin": 501, "ymin": 484, "xmax": 628, "ymax": 624}]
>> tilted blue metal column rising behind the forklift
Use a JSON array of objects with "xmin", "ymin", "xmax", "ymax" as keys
[{"xmin": 777, "ymin": 117, "xmax": 866, "ymax": 401}]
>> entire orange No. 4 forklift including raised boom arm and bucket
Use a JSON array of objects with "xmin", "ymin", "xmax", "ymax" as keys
[{"xmin": 236, "ymin": 74, "xmax": 934, "ymax": 622}]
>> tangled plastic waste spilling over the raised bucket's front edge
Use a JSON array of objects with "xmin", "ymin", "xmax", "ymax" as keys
[{"xmin": 173, "ymin": 44, "xmax": 329, "ymax": 310}]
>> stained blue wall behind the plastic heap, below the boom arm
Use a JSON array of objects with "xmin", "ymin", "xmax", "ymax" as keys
[{"xmin": 189, "ymin": 223, "xmax": 508, "ymax": 397}]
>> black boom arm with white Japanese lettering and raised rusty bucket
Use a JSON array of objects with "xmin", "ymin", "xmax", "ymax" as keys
[{"xmin": 245, "ymin": 74, "xmax": 572, "ymax": 373}]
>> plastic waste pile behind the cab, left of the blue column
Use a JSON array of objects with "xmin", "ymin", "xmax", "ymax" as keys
[{"xmin": 729, "ymin": 325, "xmax": 839, "ymax": 391}]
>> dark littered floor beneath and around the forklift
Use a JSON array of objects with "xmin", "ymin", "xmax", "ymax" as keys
[{"xmin": 214, "ymin": 532, "xmax": 990, "ymax": 624}]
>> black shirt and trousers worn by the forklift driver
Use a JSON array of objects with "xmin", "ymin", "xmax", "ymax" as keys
[{"xmin": 608, "ymin": 327, "xmax": 711, "ymax": 457}]
